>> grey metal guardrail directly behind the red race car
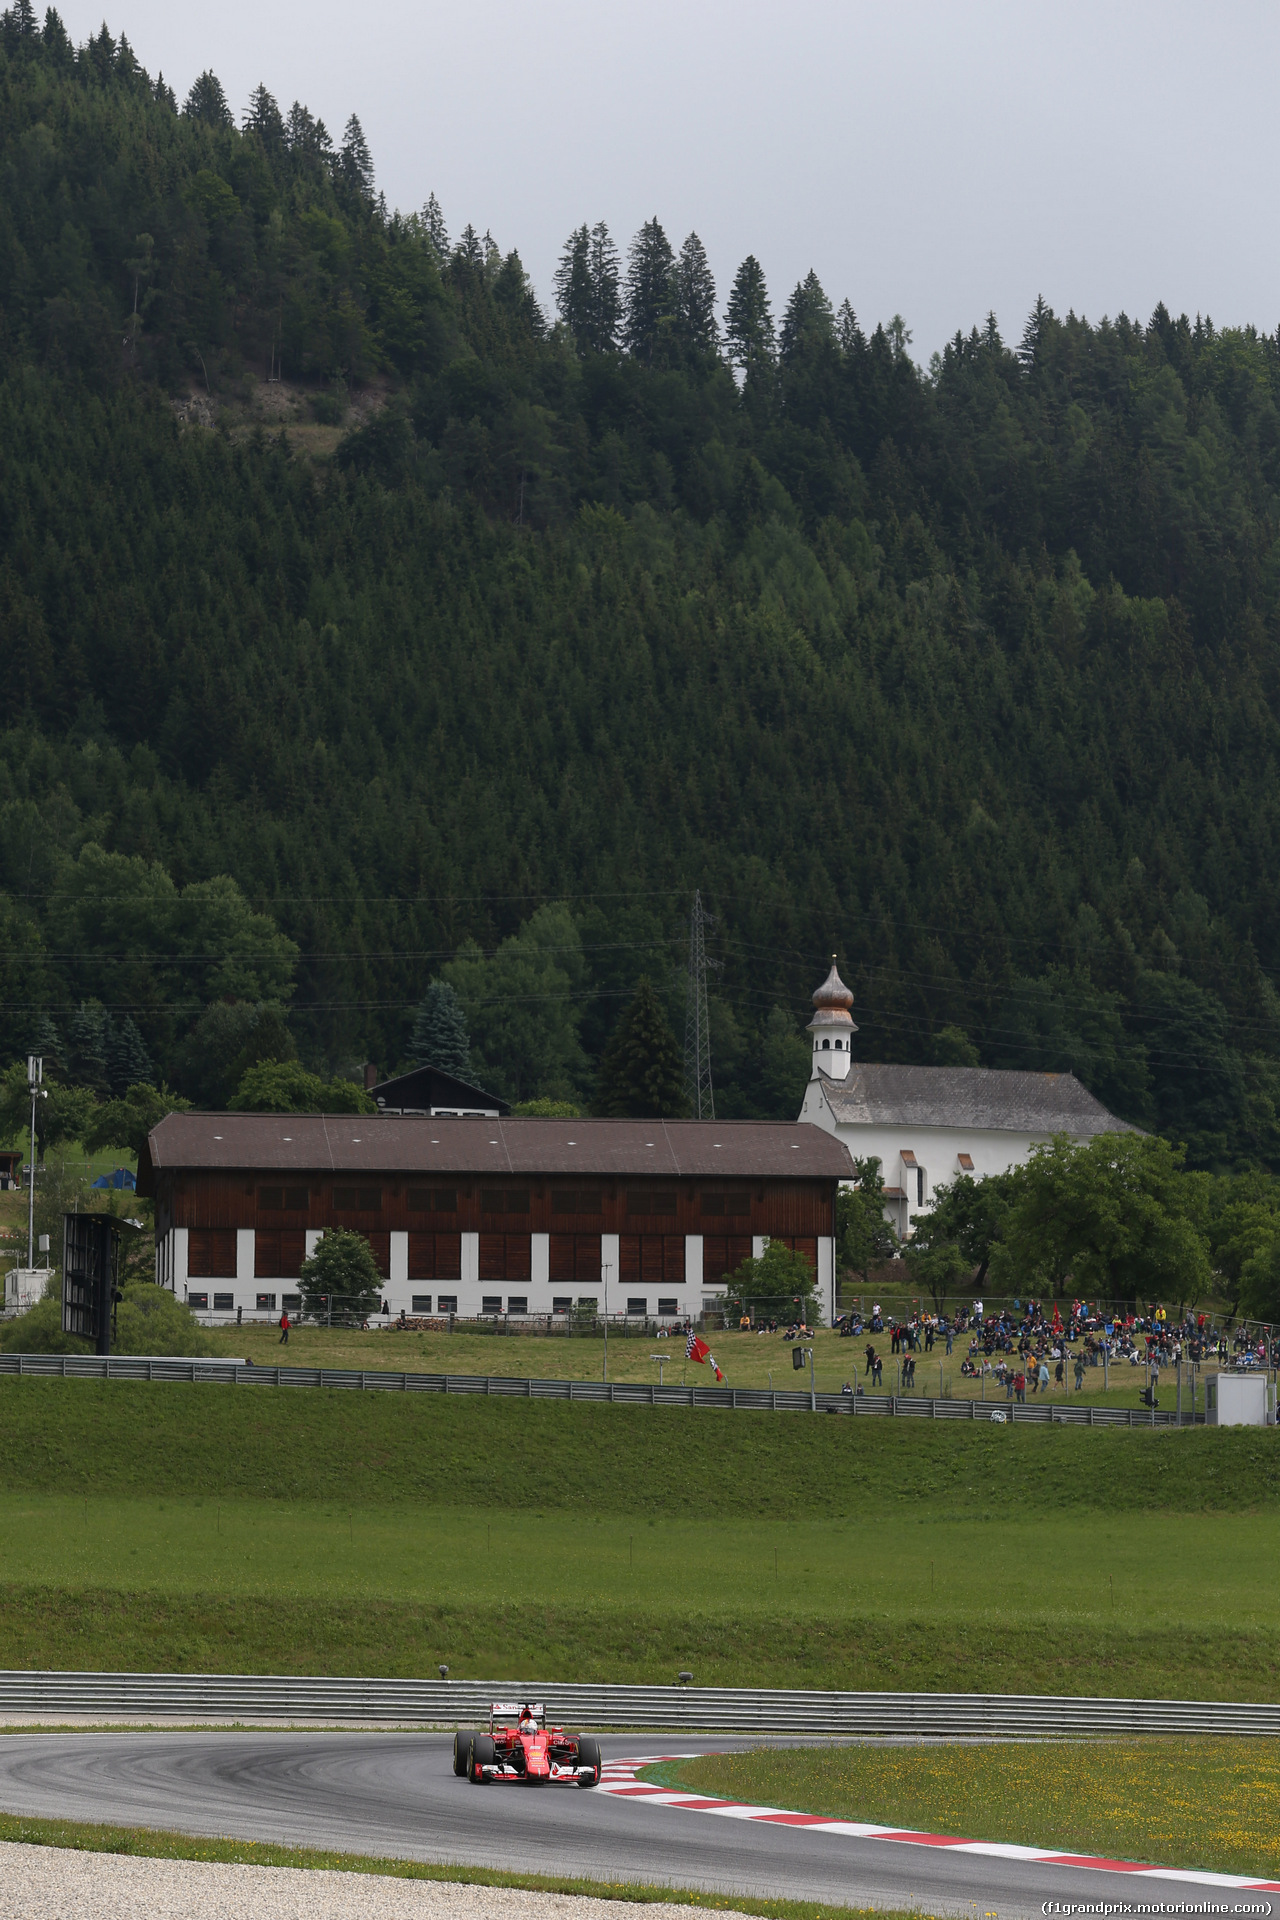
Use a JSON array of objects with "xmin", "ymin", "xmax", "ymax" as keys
[{"xmin": 0, "ymin": 1672, "xmax": 1280, "ymax": 1740}]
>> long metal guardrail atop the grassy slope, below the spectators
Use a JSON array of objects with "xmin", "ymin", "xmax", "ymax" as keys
[{"xmin": 0, "ymin": 1354, "xmax": 1205, "ymax": 1427}]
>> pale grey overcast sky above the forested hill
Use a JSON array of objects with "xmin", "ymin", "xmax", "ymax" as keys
[{"xmin": 61, "ymin": 0, "xmax": 1280, "ymax": 359}]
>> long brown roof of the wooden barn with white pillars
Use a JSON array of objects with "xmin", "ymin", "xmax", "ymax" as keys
[{"xmin": 138, "ymin": 1114, "xmax": 852, "ymax": 1190}]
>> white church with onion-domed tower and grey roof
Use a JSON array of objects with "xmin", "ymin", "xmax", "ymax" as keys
[{"xmin": 800, "ymin": 958, "xmax": 1136, "ymax": 1238}]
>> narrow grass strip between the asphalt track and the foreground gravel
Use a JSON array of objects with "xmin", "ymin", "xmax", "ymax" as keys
[{"xmin": 0, "ymin": 1814, "xmax": 927, "ymax": 1920}]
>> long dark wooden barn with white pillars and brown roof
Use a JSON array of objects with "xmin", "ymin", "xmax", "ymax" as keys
[{"xmin": 138, "ymin": 1114, "xmax": 852, "ymax": 1319}]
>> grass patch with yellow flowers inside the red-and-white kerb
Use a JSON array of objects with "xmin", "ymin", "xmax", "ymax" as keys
[{"xmin": 645, "ymin": 1740, "xmax": 1280, "ymax": 1880}]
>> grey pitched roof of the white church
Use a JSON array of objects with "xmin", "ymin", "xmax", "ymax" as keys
[{"xmin": 819, "ymin": 1062, "xmax": 1138, "ymax": 1139}]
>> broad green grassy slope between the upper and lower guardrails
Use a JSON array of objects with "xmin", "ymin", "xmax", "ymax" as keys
[{"xmin": 0, "ymin": 1379, "xmax": 1280, "ymax": 1699}]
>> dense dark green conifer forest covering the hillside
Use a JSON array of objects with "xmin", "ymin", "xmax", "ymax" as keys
[{"xmin": 0, "ymin": 0, "xmax": 1280, "ymax": 1167}]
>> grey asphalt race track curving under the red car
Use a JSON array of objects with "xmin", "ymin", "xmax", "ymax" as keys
[{"xmin": 0, "ymin": 1732, "xmax": 1267, "ymax": 1916}]
